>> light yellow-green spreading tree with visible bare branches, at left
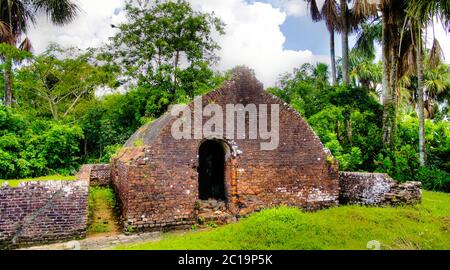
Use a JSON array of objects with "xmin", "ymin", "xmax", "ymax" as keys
[{"xmin": 15, "ymin": 44, "xmax": 116, "ymax": 120}]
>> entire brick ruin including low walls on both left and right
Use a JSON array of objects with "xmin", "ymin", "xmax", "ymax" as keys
[{"xmin": 0, "ymin": 69, "xmax": 421, "ymax": 249}]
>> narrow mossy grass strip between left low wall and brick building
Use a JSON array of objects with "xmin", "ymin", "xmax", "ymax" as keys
[{"xmin": 87, "ymin": 187, "xmax": 120, "ymax": 236}]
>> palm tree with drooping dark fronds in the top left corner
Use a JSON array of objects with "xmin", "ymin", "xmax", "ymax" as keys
[{"xmin": 0, "ymin": 0, "xmax": 79, "ymax": 106}]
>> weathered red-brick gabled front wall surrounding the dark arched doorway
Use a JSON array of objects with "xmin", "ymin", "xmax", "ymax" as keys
[{"xmin": 111, "ymin": 68, "xmax": 339, "ymax": 230}]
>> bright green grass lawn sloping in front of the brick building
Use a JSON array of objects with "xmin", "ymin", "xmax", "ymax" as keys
[{"xmin": 118, "ymin": 191, "xmax": 450, "ymax": 250}]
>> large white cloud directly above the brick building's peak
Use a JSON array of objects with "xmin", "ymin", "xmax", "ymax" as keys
[{"xmin": 191, "ymin": 0, "xmax": 329, "ymax": 87}]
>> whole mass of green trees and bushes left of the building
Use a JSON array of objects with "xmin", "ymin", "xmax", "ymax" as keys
[{"xmin": 0, "ymin": 0, "xmax": 225, "ymax": 174}]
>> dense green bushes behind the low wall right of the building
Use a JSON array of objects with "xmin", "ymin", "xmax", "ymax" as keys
[{"xmin": 269, "ymin": 64, "xmax": 450, "ymax": 191}]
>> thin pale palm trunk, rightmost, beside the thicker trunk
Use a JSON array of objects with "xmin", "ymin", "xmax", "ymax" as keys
[{"xmin": 416, "ymin": 27, "xmax": 425, "ymax": 166}]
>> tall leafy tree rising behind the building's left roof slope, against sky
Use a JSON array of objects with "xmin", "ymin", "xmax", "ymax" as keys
[{"xmin": 104, "ymin": 0, "xmax": 224, "ymax": 101}]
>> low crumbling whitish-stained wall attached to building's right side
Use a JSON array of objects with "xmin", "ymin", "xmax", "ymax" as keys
[{"xmin": 339, "ymin": 172, "xmax": 422, "ymax": 206}]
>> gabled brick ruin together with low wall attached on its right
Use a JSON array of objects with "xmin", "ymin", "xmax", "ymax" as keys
[{"xmin": 103, "ymin": 68, "xmax": 421, "ymax": 231}]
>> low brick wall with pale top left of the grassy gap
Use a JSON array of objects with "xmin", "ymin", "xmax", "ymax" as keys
[{"xmin": 0, "ymin": 179, "xmax": 89, "ymax": 249}]
